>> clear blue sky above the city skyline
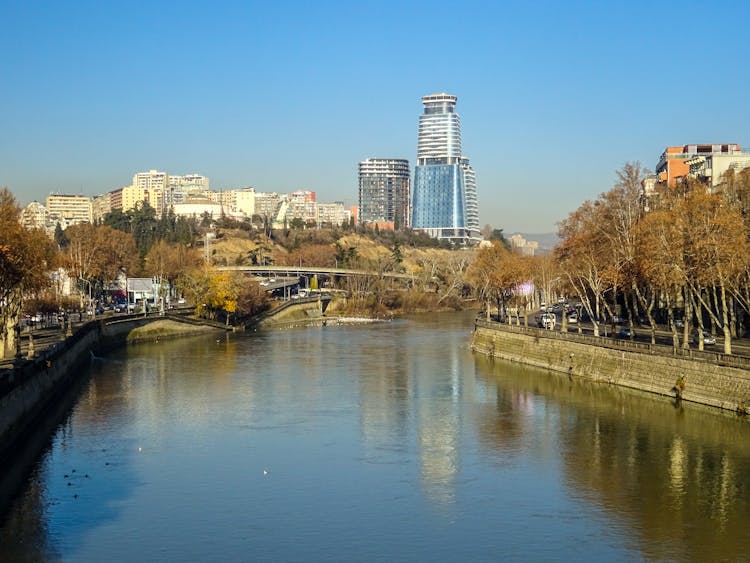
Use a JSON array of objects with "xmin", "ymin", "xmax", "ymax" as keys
[{"xmin": 0, "ymin": 0, "xmax": 750, "ymax": 233}]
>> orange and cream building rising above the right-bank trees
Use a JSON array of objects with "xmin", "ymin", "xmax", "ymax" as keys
[{"xmin": 655, "ymin": 143, "xmax": 750, "ymax": 188}]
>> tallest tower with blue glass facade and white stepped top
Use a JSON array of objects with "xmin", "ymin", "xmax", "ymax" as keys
[{"xmin": 411, "ymin": 93, "xmax": 481, "ymax": 244}]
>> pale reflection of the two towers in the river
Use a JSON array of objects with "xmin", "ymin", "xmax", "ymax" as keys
[{"xmin": 350, "ymin": 322, "xmax": 473, "ymax": 506}]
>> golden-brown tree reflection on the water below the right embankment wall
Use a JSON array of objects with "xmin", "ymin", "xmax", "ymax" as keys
[{"xmin": 476, "ymin": 357, "xmax": 750, "ymax": 561}]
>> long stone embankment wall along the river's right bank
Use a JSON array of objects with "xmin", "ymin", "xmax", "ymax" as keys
[{"xmin": 472, "ymin": 321, "xmax": 750, "ymax": 412}]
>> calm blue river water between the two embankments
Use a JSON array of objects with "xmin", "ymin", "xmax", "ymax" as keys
[{"xmin": 0, "ymin": 313, "xmax": 750, "ymax": 562}]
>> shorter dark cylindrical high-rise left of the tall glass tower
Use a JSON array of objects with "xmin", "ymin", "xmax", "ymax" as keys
[{"xmin": 359, "ymin": 158, "xmax": 411, "ymax": 229}]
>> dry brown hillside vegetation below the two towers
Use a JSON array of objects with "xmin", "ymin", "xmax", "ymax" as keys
[{"xmin": 209, "ymin": 229, "xmax": 475, "ymax": 316}]
